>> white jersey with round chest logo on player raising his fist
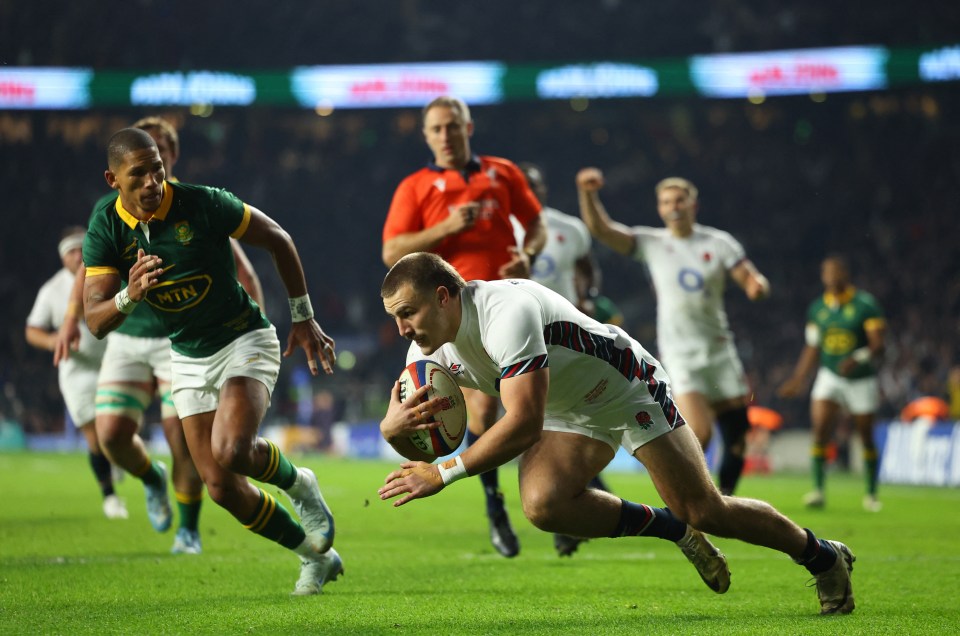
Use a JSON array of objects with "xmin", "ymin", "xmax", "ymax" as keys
[{"xmin": 632, "ymin": 224, "xmax": 746, "ymax": 357}]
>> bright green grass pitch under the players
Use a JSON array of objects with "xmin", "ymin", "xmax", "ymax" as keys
[{"xmin": 0, "ymin": 453, "xmax": 960, "ymax": 636}]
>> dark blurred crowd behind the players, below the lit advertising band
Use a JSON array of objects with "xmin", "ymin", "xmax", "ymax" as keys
[{"xmin": 0, "ymin": 83, "xmax": 960, "ymax": 432}]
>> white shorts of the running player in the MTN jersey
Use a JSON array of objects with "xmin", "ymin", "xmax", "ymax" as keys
[{"xmin": 170, "ymin": 325, "xmax": 280, "ymax": 418}]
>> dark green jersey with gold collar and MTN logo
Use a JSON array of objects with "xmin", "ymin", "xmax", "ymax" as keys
[{"xmin": 83, "ymin": 181, "xmax": 270, "ymax": 358}]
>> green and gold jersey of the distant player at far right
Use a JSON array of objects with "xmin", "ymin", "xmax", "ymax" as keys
[{"xmin": 807, "ymin": 287, "xmax": 885, "ymax": 378}]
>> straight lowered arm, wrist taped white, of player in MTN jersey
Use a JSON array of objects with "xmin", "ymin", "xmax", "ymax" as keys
[{"xmin": 239, "ymin": 206, "xmax": 337, "ymax": 375}]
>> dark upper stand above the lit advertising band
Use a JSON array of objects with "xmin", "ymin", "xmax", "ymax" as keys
[{"xmin": 0, "ymin": 0, "xmax": 960, "ymax": 69}]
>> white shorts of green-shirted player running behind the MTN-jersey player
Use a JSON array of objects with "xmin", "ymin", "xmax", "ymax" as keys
[{"xmin": 100, "ymin": 332, "xmax": 170, "ymax": 384}]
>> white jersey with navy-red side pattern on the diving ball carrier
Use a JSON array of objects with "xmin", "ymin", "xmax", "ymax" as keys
[{"xmin": 407, "ymin": 279, "xmax": 682, "ymax": 425}]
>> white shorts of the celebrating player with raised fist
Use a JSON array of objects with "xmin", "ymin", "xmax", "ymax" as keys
[{"xmin": 660, "ymin": 344, "xmax": 749, "ymax": 402}]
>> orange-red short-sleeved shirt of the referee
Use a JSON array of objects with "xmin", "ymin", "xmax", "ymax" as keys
[{"xmin": 383, "ymin": 155, "xmax": 542, "ymax": 280}]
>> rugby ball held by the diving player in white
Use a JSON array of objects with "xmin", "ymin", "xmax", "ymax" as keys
[{"xmin": 400, "ymin": 360, "xmax": 467, "ymax": 457}]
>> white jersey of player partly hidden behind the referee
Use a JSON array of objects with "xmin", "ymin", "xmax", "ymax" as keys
[{"xmin": 530, "ymin": 208, "xmax": 590, "ymax": 303}]
